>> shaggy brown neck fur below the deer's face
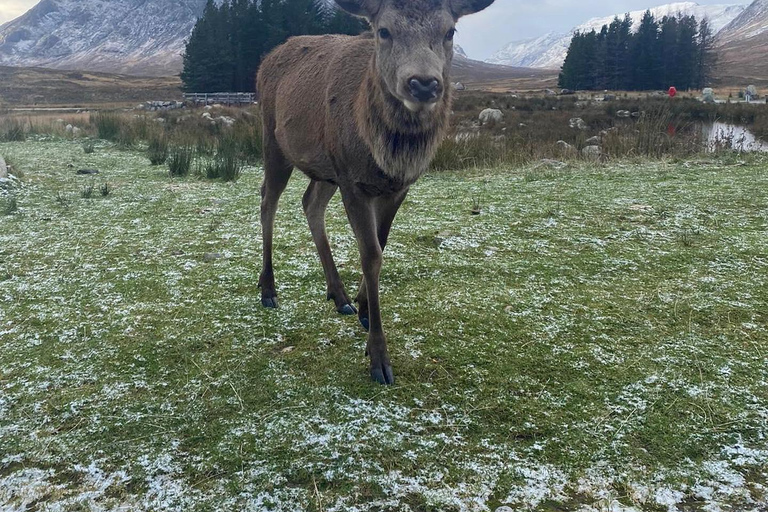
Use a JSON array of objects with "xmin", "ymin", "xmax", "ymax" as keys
[{"xmin": 355, "ymin": 57, "xmax": 451, "ymax": 185}]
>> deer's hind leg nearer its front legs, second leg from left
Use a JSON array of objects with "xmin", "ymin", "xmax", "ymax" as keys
[{"xmin": 302, "ymin": 180, "xmax": 357, "ymax": 315}]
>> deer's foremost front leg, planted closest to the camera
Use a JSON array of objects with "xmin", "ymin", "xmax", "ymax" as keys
[{"xmin": 342, "ymin": 187, "xmax": 395, "ymax": 384}]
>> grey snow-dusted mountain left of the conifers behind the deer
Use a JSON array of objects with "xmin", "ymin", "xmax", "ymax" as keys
[{"xmin": 0, "ymin": 0, "xmax": 205, "ymax": 76}]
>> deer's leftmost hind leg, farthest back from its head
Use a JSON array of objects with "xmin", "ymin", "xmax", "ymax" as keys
[{"xmin": 259, "ymin": 146, "xmax": 293, "ymax": 308}]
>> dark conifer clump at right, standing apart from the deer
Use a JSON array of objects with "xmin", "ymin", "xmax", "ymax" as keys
[{"xmin": 559, "ymin": 10, "xmax": 716, "ymax": 91}]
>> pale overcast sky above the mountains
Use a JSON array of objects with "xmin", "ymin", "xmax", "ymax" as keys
[{"xmin": 0, "ymin": 0, "xmax": 742, "ymax": 60}]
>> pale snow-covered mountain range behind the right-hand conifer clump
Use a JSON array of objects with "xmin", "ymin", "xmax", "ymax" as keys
[{"xmin": 487, "ymin": 0, "xmax": 748, "ymax": 69}]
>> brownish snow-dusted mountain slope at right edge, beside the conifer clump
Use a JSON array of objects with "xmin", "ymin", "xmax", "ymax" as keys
[{"xmin": 715, "ymin": 0, "xmax": 768, "ymax": 85}]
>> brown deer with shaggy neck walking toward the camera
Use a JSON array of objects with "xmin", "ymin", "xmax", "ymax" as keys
[{"xmin": 256, "ymin": 0, "xmax": 494, "ymax": 385}]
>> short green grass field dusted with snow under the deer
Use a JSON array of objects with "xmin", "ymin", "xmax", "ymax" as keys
[{"xmin": 0, "ymin": 136, "xmax": 768, "ymax": 512}]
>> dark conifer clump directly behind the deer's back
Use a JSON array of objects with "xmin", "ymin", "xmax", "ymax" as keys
[{"xmin": 181, "ymin": 0, "xmax": 366, "ymax": 92}]
